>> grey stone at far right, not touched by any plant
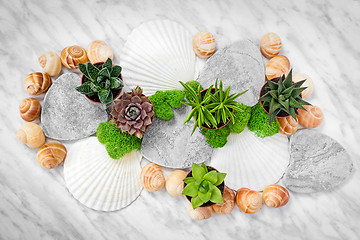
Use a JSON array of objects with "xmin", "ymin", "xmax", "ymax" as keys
[{"xmin": 283, "ymin": 129, "xmax": 353, "ymax": 193}]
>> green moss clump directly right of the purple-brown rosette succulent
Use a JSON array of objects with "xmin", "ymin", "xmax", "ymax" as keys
[{"xmin": 149, "ymin": 90, "xmax": 185, "ymax": 121}]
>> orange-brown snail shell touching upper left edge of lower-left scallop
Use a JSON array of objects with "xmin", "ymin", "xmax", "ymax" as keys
[{"xmin": 36, "ymin": 142, "xmax": 67, "ymax": 169}]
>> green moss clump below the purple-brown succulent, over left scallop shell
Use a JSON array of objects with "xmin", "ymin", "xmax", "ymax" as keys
[{"xmin": 96, "ymin": 122, "xmax": 141, "ymax": 159}]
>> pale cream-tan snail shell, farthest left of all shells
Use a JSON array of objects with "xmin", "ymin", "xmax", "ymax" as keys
[{"xmin": 16, "ymin": 122, "xmax": 45, "ymax": 148}]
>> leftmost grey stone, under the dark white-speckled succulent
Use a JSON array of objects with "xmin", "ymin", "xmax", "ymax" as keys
[{"xmin": 41, "ymin": 73, "xmax": 109, "ymax": 140}]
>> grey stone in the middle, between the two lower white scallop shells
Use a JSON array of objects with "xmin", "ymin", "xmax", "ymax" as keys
[{"xmin": 141, "ymin": 105, "xmax": 213, "ymax": 168}]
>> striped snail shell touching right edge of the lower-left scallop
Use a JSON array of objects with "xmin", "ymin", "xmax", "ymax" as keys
[{"xmin": 140, "ymin": 163, "xmax": 165, "ymax": 192}]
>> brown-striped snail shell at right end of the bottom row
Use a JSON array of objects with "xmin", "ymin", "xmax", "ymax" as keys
[{"xmin": 262, "ymin": 184, "xmax": 290, "ymax": 208}]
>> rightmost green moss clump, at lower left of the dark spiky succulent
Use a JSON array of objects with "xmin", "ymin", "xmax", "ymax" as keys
[{"xmin": 248, "ymin": 103, "xmax": 280, "ymax": 138}]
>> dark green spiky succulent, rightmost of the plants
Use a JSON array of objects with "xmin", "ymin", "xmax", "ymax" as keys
[{"xmin": 259, "ymin": 70, "xmax": 311, "ymax": 125}]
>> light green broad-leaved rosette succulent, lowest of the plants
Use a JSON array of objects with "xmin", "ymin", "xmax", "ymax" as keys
[{"xmin": 182, "ymin": 163, "xmax": 226, "ymax": 209}]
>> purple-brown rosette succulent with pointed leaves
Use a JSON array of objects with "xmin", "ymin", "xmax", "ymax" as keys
[{"xmin": 110, "ymin": 86, "xmax": 155, "ymax": 138}]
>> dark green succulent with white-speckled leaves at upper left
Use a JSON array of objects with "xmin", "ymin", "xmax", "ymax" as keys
[{"xmin": 76, "ymin": 58, "xmax": 124, "ymax": 107}]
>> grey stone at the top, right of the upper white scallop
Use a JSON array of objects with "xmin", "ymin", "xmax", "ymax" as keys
[{"xmin": 198, "ymin": 40, "xmax": 265, "ymax": 106}]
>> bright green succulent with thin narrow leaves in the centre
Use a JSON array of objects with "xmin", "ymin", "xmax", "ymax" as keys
[{"xmin": 180, "ymin": 79, "xmax": 247, "ymax": 133}]
